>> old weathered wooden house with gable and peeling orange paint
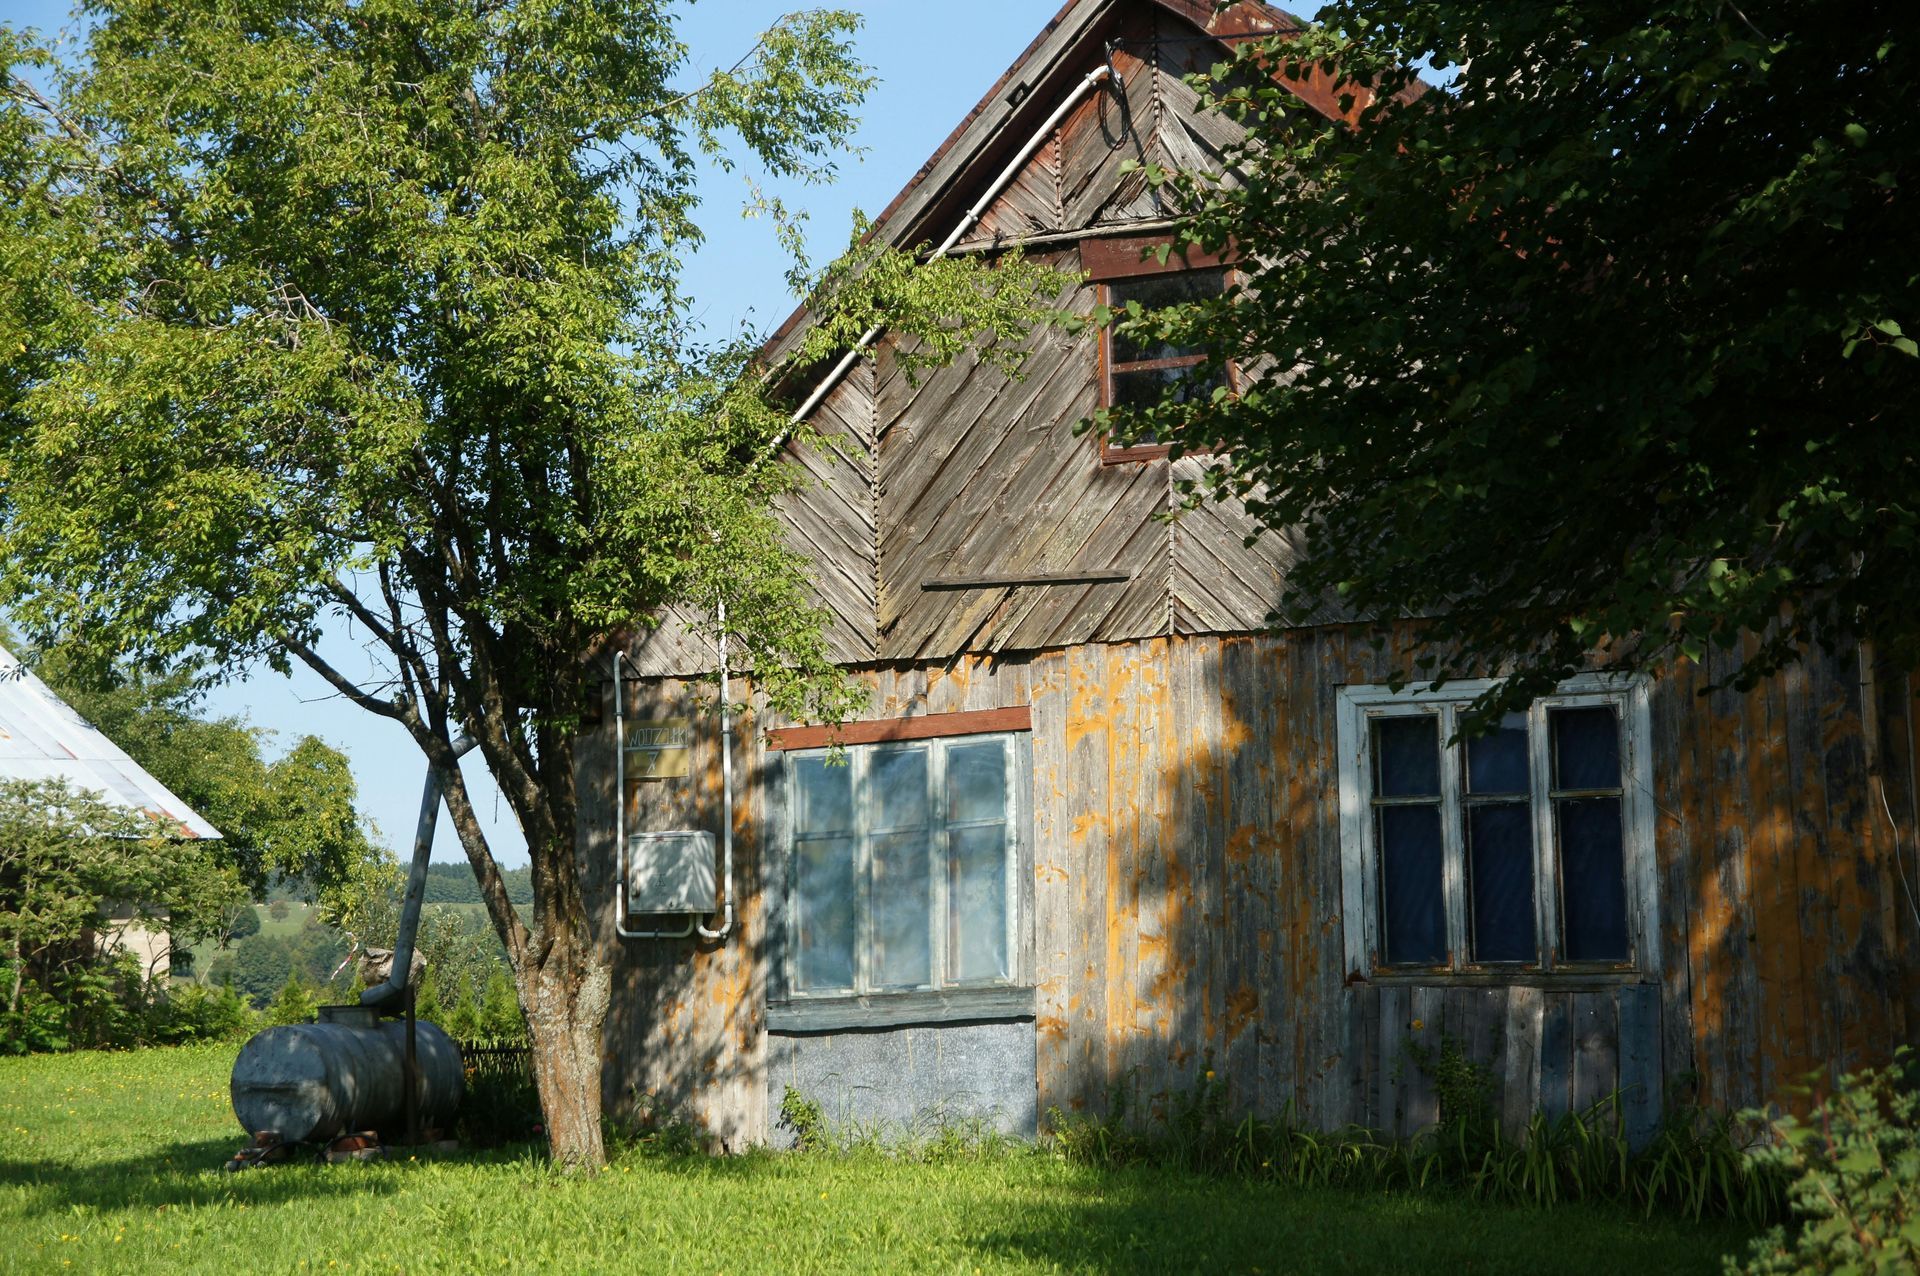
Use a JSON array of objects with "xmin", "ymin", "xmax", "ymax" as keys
[{"xmin": 582, "ymin": 0, "xmax": 1920, "ymax": 1146}]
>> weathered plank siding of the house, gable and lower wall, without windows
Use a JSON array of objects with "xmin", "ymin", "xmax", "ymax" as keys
[{"xmin": 582, "ymin": 0, "xmax": 1920, "ymax": 1146}]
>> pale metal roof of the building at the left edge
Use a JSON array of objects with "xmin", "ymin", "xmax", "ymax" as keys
[{"xmin": 0, "ymin": 647, "xmax": 221, "ymax": 839}]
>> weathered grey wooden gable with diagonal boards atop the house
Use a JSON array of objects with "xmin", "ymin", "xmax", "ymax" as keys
[{"xmin": 630, "ymin": 0, "xmax": 1344, "ymax": 675}]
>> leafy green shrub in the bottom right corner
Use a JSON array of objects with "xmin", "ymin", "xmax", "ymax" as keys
[{"xmin": 1726, "ymin": 1046, "xmax": 1920, "ymax": 1276}]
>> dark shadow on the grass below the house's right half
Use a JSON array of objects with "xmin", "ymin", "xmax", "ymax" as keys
[{"xmin": 970, "ymin": 1170, "xmax": 1751, "ymax": 1276}]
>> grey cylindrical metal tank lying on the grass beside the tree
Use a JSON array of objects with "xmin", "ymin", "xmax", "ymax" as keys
[{"xmin": 232, "ymin": 1017, "xmax": 465, "ymax": 1142}]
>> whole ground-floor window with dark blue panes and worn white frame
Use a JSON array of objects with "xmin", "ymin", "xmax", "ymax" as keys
[{"xmin": 1340, "ymin": 683, "xmax": 1653, "ymax": 971}]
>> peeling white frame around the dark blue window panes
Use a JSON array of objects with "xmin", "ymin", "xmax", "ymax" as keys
[{"xmin": 1336, "ymin": 673, "xmax": 1661, "ymax": 981}]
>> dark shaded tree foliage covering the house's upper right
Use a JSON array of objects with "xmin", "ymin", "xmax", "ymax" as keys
[{"xmin": 1121, "ymin": 0, "xmax": 1920, "ymax": 704}]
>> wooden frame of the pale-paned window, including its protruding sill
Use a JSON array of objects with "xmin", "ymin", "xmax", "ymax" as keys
[{"xmin": 764, "ymin": 721, "xmax": 1035, "ymax": 1032}]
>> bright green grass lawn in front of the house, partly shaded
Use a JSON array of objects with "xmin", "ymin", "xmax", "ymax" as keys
[{"xmin": 0, "ymin": 1046, "xmax": 1745, "ymax": 1274}]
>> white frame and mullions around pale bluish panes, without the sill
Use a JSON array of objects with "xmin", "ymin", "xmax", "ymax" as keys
[{"xmin": 781, "ymin": 731, "xmax": 1027, "ymax": 1002}]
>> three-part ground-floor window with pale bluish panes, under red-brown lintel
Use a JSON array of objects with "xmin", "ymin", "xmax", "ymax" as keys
[{"xmin": 787, "ymin": 735, "xmax": 1020, "ymax": 996}]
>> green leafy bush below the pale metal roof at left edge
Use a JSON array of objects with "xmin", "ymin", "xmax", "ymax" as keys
[{"xmin": 0, "ymin": 779, "xmax": 236, "ymax": 1053}]
